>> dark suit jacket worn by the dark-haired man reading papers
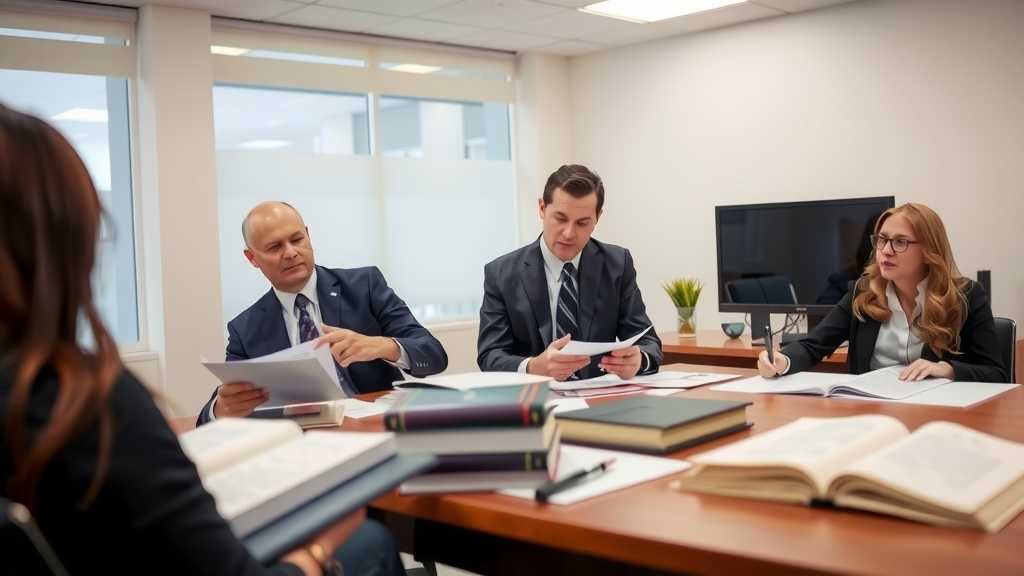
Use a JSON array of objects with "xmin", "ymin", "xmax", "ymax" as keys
[{"xmin": 476, "ymin": 238, "xmax": 662, "ymax": 378}]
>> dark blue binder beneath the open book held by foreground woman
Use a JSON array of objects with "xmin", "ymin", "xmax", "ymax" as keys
[{"xmin": 243, "ymin": 454, "xmax": 437, "ymax": 564}]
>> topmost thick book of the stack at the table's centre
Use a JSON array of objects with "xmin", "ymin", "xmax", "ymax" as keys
[{"xmin": 384, "ymin": 382, "xmax": 548, "ymax": 433}]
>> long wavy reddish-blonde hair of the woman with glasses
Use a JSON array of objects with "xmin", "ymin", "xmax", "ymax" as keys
[{"xmin": 853, "ymin": 204, "xmax": 971, "ymax": 358}]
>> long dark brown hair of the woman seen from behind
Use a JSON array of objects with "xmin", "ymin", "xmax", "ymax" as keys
[{"xmin": 0, "ymin": 105, "xmax": 121, "ymax": 509}]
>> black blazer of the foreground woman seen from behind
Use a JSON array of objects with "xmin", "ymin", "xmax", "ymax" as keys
[{"xmin": 0, "ymin": 362, "xmax": 302, "ymax": 575}]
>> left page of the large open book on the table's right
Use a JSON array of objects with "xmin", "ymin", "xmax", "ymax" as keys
[{"xmin": 690, "ymin": 415, "xmax": 908, "ymax": 495}]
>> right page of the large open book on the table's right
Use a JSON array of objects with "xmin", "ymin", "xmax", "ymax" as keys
[{"xmin": 831, "ymin": 422, "xmax": 1024, "ymax": 513}]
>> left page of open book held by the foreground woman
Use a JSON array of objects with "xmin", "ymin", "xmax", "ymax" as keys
[{"xmin": 178, "ymin": 418, "xmax": 302, "ymax": 477}]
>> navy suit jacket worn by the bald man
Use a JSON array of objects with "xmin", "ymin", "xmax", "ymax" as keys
[{"xmin": 198, "ymin": 266, "xmax": 447, "ymax": 424}]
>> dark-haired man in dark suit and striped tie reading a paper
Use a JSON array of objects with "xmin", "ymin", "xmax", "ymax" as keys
[{"xmin": 476, "ymin": 165, "xmax": 662, "ymax": 380}]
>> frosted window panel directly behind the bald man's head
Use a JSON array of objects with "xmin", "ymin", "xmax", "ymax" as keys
[{"xmin": 217, "ymin": 151, "xmax": 382, "ymax": 321}]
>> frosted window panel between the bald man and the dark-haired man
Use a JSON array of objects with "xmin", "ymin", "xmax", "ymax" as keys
[{"xmin": 381, "ymin": 158, "xmax": 516, "ymax": 322}]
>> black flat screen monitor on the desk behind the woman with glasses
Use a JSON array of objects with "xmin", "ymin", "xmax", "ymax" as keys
[{"xmin": 715, "ymin": 196, "xmax": 895, "ymax": 338}]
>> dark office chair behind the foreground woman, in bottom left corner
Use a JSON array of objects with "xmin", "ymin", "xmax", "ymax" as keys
[{"xmin": 0, "ymin": 496, "xmax": 68, "ymax": 576}]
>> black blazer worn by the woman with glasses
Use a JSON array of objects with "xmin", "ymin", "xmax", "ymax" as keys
[{"xmin": 782, "ymin": 281, "xmax": 1009, "ymax": 382}]
